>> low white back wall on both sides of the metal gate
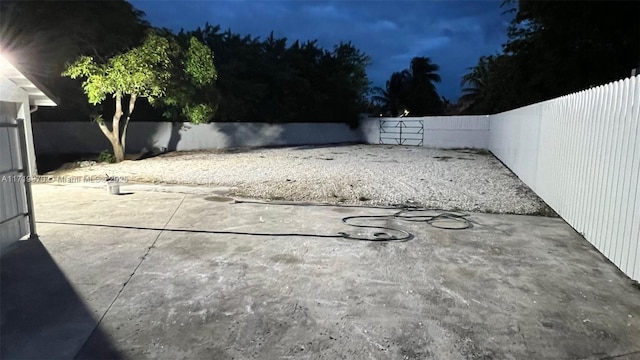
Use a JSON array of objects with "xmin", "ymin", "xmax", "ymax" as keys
[{"xmin": 33, "ymin": 116, "xmax": 489, "ymax": 154}]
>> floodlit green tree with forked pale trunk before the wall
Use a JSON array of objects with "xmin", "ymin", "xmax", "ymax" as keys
[{"xmin": 62, "ymin": 33, "xmax": 216, "ymax": 162}]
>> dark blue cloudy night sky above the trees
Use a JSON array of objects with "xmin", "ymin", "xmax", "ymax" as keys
[{"xmin": 130, "ymin": 0, "xmax": 511, "ymax": 101}]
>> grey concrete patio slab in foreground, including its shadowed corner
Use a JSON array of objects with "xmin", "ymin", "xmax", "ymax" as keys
[{"xmin": 0, "ymin": 185, "xmax": 640, "ymax": 359}]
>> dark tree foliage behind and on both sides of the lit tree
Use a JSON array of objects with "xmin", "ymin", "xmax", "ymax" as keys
[{"xmin": 0, "ymin": 0, "xmax": 369, "ymax": 126}]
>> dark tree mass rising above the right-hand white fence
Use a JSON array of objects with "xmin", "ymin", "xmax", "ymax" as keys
[{"xmin": 461, "ymin": 0, "xmax": 640, "ymax": 112}]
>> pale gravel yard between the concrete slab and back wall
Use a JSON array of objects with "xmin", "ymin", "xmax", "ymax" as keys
[{"xmin": 50, "ymin": 145, "xmax": 551, "ymax": 214}]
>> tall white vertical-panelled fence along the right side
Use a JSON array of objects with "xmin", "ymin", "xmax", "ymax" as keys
[{"xmin": 489, "ymin": 76, "xmax": 640, "ymax": 280}]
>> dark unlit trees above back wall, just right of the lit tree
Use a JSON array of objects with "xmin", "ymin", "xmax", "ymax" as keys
[{"xmin": 178, "ymin": 24, "xmax": 369, "ymax": 125}]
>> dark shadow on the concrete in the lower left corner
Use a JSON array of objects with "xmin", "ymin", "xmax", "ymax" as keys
[{"xmin": 0, "ymin": 239, "xmax": 123, "ymax": 360}]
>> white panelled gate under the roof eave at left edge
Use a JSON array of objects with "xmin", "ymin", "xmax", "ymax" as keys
[{"xmin": 0, "ymin": 102, "xmax": 36, "ymax": 254}]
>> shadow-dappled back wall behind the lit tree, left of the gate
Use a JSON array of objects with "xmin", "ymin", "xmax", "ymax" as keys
[{"xmin": 33, "ymin": 121, "xmax": 362, "ymax": 154}]
